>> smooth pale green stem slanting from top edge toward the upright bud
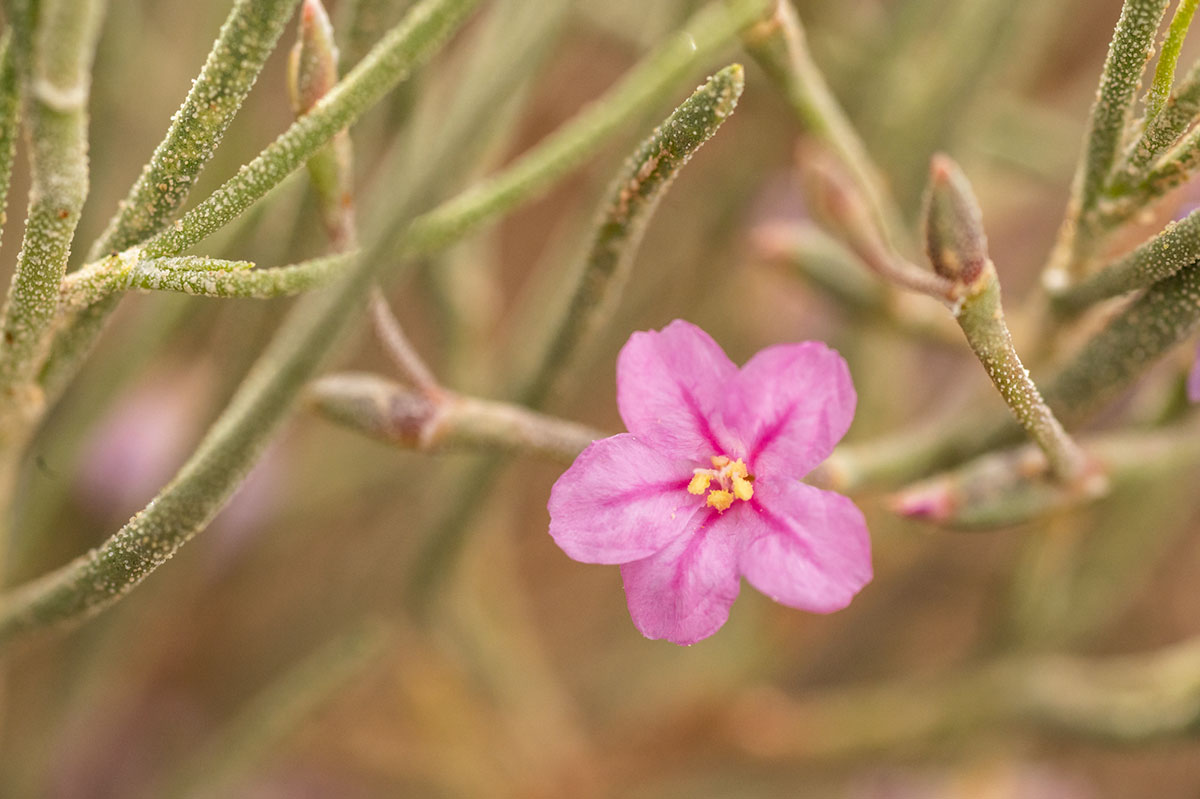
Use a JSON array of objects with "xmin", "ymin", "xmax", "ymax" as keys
[{"xmin": 743, "ymin": 0, "xmax": 908, "ymax": 244}]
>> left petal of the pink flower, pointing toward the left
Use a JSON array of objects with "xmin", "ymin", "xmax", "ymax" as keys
[{"xmin": 548, "ymin": 433, "xmax": 702, "ymax": 564}]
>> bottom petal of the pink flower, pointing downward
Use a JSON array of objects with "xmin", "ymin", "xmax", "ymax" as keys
[{"xmin": 620, "ymin": 509, "xmax": 742, "ymax": 645}]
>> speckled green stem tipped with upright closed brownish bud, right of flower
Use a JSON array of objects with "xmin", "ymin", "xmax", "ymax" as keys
[{"xmin": 925, "ymin": 155, "xmax": 1087, "ymax": 483}]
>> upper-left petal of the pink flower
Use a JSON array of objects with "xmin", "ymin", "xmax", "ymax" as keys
[{"xmin": 617, "ymin": 319, "xmax": 738, "ymax": 462}]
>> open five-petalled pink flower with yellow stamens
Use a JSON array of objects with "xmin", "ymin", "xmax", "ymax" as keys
[{"xmin": 550, "ymin": 319, "xmax": 871, "ymax": 644}]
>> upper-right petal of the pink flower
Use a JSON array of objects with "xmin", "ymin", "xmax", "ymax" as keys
[{"xmin": 721, "ymin": 341, "xmax": 857, "ymax": 477}]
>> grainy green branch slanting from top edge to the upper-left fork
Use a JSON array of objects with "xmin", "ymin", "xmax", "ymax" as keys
[{"xmin": 88, "ymin": 0, "xmax": 298, "ymax": 260}]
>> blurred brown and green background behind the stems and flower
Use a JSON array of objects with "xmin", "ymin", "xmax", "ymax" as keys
[{"xmin": 7, "ymin": 0, "xmax": 1200, "ymax": 799}]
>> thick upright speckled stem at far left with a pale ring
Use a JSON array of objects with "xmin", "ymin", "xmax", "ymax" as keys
[{"xmin": 0, "ymin": 0, "xmax": 103, "ymax": 444}]
